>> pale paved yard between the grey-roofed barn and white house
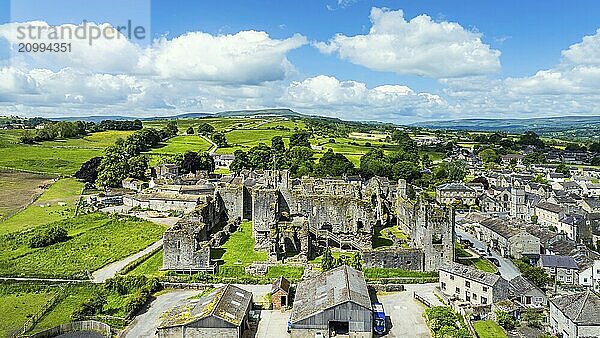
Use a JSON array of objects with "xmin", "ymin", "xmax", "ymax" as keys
[{"xmin": 377, "ymin": 283, "xmax": 437, "ymax": 338}]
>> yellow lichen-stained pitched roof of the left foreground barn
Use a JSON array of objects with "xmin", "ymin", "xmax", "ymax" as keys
[{"xmin": 159, "ymin": 284, "xmax": 252, "ymax": 328}]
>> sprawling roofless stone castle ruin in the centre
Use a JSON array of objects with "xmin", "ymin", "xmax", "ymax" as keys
[{"xmin": 130, "ymin": 168, "xmax": 454, "ymax": 272}]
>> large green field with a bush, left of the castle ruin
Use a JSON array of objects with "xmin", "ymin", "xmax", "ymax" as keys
[{"xmin": 0, "ymin": 213, "xmax": 166, "ymax": 279}]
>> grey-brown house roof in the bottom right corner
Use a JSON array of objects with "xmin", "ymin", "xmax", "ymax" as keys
[{"xmin": 550, "ymin": 291, "xmax": 600, "ymax": 326}]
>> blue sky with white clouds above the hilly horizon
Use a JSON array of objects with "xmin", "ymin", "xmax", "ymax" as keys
[{"xmin": 0, "ymin": 0, "xmax": 600, "ymax": 121}]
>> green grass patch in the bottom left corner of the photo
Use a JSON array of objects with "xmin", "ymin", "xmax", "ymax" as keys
[{"xmin": 0, "ymin": 283, "xmax": 53, "ymax": 337}]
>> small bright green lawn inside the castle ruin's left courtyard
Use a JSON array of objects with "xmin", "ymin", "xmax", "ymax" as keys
[{"xmin": 221, "ymin": 222, "xmax": 268, "ymax": 266}]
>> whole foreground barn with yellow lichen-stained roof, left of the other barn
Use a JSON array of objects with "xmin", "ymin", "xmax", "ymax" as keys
[{"xmin": 158, "ymin": 284, "xmax": 252, "ymax": 338}]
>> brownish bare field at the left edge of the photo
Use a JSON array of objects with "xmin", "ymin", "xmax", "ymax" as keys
[{"xmin": 0, "ymin": 171, "xmax": 52, "ymax": 219}]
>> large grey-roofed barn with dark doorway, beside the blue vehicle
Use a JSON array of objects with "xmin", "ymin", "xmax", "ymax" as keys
[{"xmin": 290, "ymin": 266, "xmax": 373, "ymax": 338}]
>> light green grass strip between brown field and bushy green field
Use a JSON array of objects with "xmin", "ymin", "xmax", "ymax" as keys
[{"xmin": 0, "ymin": 178, "xmax": 83, "ymax": 235}]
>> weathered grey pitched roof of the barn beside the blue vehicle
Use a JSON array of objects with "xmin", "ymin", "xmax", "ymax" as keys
[{"xmin": 291, "ymin": 265, "xmax": 371, "ymax": 323}]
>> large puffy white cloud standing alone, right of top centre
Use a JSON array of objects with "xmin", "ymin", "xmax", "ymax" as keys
[{"xmin": 314, "ymin": 8, "xmax": 500, "ymax": 78}]
